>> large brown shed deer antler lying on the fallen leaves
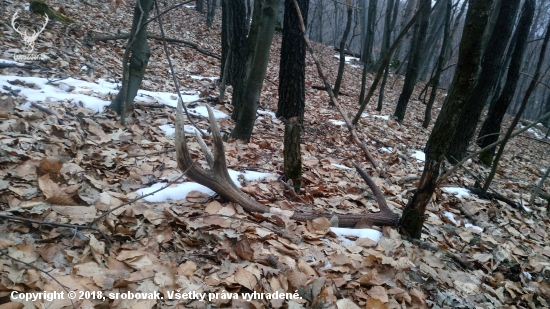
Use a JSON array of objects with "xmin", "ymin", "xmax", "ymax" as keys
[{"xmin": 175, "ymin": 100, "xmax": 399, "ymax": 227}]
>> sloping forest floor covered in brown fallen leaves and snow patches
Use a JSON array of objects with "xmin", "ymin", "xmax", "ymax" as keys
[{"xmin": 0, "ymin": 0, "xmax": 550, "ymax": 309}]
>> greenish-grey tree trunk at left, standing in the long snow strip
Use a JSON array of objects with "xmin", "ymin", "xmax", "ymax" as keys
[{"xmin": 109, "ymin": 0, "xmax": 153, "ymax": 123}]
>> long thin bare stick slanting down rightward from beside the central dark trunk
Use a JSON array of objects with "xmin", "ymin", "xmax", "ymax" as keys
[{"xmin": 292, "ymin": 0, "xmax": 384, "ymax": 170}]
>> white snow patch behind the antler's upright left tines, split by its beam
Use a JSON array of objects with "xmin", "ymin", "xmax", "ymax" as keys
[{"xmin": 136, "ymin": 169, "xmax": 273, "ymax": 202}]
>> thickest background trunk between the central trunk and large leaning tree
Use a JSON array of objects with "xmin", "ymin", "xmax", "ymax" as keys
[{"xmin": 393, "ymin": 0, "xmax": 431, "ymax": 122}]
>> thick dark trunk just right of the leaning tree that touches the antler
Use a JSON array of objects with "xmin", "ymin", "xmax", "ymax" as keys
[{"xmin": 447, "ymin": 0, "xmax": 520, "ymax": 163}]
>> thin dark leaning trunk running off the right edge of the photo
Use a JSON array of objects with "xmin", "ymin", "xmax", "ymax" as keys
[{"xmin": 482, "ymin": 0, "xmax": 550, "ymax": 193}]
